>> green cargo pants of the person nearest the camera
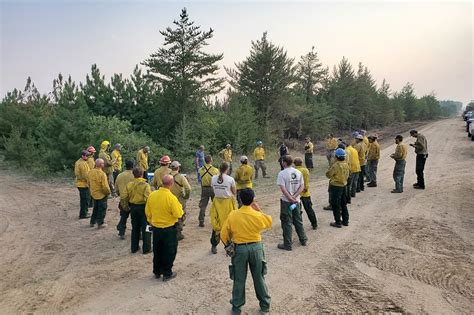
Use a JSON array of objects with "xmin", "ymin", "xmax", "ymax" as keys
[{"xmin": 229, "ymin": 242, "xmax": 271, "ymax": 313}]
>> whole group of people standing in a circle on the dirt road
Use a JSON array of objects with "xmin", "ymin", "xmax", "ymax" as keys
[{"xmin": 75, "ymin": 130, "xmax": 428, "ymax": 313}]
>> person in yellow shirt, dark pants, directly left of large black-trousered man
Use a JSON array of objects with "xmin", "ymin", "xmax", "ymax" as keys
[{"xmin": 120, "ymin": 166, "xmax": 151, "ymax": 255}]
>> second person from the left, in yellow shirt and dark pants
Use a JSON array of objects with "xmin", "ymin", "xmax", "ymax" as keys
[{"xmin": 87, "ymin": 158, "xmax": 110, "ymax": 229}]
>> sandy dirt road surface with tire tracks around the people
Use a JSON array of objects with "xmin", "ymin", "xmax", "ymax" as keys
[{"xmin": 0, "ymin": 119, "xmax": 474, "ymax": 314}]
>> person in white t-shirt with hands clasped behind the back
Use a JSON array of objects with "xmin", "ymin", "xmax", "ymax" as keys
[{"xmin": 277, "ymin": 155, "xmax": 308, "ymax": 251}]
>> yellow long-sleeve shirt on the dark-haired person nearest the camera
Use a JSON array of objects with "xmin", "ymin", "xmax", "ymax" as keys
[{"xmin": 221, "ymin": 206, "xmax": 272, "ymax": 244}]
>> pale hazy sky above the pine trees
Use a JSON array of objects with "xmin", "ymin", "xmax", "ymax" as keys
[{"xmin": 0, "ymin": 0, "xmax": 474, "ymax": 103}]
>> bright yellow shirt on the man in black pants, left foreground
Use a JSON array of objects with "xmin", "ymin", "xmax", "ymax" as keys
[{"xmin": 145, "ymin": 187, "xmax": 184, "ymax": 228}]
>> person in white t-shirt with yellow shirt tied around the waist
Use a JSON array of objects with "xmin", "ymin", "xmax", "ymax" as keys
[{"xmin": 209, "ymin": 162, "xmax": 237, "ymax": 254}]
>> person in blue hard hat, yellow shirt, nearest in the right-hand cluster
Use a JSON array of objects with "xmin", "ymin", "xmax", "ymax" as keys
[{"xmin": 326, "ymin": 148, "xmax": 349, "ymax": 228}]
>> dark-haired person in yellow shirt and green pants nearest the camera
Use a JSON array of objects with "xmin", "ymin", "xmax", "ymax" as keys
[{"xmin": 221, "ymin": 189, "xmax": 272, "ymax": 314}]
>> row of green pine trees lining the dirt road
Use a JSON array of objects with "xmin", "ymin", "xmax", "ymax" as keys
[{"xmin": 0, "ymin": 9, "xmax": 462, "ymax": 172}]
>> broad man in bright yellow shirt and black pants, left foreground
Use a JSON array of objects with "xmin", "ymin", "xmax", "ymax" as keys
[{"xmin": 145, "ymin": 175, "xmax": 184, "ymax": 281}]
